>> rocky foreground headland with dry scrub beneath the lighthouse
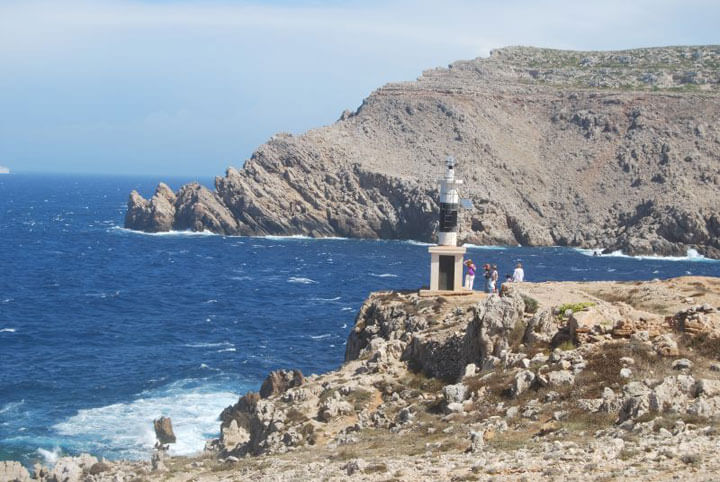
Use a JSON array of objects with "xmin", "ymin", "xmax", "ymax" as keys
[{"xmin": 8, "ymin": 277, "xmax": 720, "ymax": 482}]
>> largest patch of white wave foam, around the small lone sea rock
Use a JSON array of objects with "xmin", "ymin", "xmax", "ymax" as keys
[{"xmin": 53, "ymin": 388, "xmax": 237, "ymax": 459}]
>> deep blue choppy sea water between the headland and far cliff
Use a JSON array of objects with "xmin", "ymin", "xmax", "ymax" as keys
[{"xmin": 0, "ymin": 174, "xmax": 720, "ymax": 463}]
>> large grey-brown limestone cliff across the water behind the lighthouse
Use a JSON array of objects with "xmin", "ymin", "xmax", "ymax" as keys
[{"xmin": 125, "ymin": 46, "xmax": 720, "ymax": 257}]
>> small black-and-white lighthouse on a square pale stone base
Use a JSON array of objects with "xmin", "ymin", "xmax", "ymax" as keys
[{"xmin": 421, "ymin": 156, "xmax": 471, "ymax": 294}]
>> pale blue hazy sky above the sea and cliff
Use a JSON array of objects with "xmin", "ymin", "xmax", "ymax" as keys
[{"xmin": 0, "ymin": 0, "xmax": 720, "ymax": 176}]
